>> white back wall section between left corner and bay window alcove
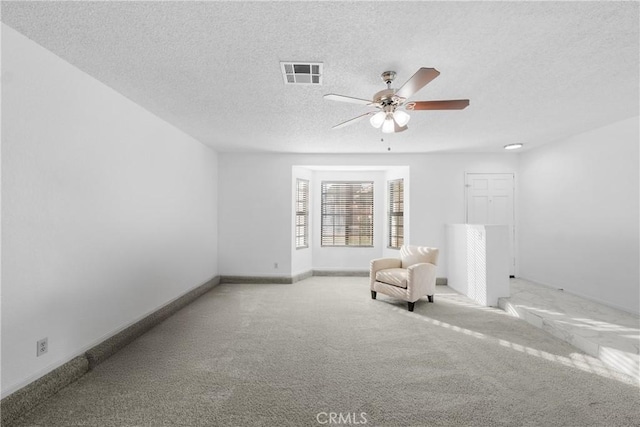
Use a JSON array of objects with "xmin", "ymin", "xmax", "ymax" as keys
[{"xmin": 218, "ymin": 153, "xmax": 294, "ymax": 276}]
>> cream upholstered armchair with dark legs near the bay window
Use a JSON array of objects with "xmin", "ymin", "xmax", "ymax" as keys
[{"xmin": 369, "ymin": 245, "xmax": 439, "ymax": 311}]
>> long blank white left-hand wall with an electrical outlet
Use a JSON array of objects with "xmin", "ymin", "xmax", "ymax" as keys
[{"xmin": 2, "ymin": 25, "xmax": 217, "ymax": 396}]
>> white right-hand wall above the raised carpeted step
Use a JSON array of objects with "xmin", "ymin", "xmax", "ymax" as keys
[{"xmin": 517, "ymin": 117, "xmax": 640, "ymax": 313}]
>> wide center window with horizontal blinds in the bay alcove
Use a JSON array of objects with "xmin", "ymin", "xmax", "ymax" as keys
[{"xmin": 321, "ymin": 181, "xmax": 373, "ymax": 246}]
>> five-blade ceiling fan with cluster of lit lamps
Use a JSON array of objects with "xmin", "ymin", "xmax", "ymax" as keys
[{"xmin": 324, "ymin": 67, "xmax": 469, "ymax": 133}]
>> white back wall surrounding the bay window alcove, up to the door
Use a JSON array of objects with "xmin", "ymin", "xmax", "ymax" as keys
[{"xmin": 219, "ymin": 153, "xmax": 518, "ymax": 277}]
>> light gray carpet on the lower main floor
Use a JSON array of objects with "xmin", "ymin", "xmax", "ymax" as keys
[{"xmin": 11, "ymin": 277, "xmax": 640, "ymax": 427}]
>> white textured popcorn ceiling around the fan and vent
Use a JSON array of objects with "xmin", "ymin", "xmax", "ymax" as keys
[{"xmin": 2, "ymin": 1, "xmax": 640, "ymax": 153}]
